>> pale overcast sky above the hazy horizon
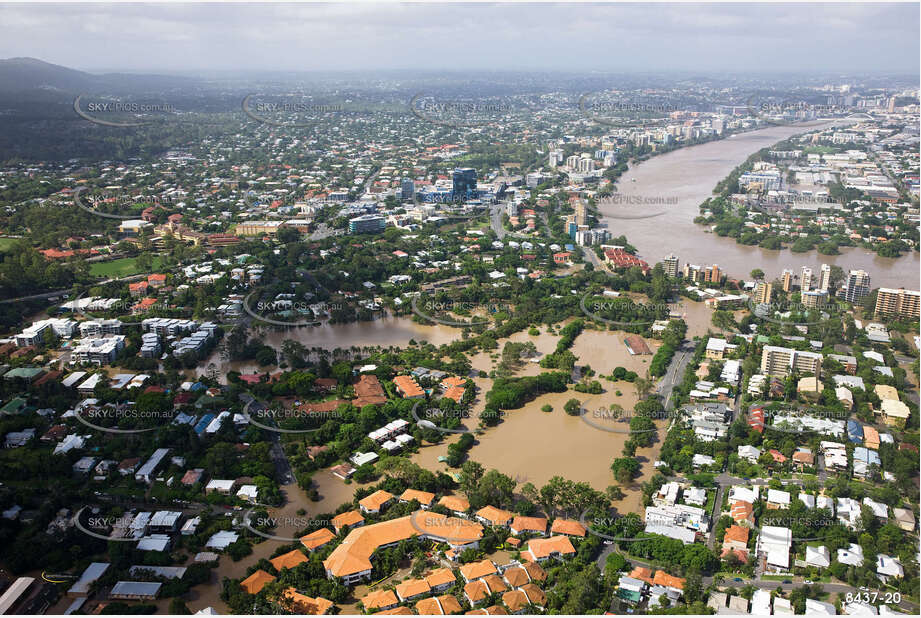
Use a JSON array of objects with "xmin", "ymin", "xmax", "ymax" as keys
[{"xmin": 0, "ymin": 3, "xmax": 919, "ymax": 73}]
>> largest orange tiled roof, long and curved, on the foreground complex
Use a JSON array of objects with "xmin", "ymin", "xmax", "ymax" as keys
[{"xmin": 323, "ymin": 511, "xmax": 483, "ymax": 577}]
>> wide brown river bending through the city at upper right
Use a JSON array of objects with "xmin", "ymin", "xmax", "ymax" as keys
[{"xmin": 601, "ymin": 127, "xmax": 919, "ymax": 289}]
